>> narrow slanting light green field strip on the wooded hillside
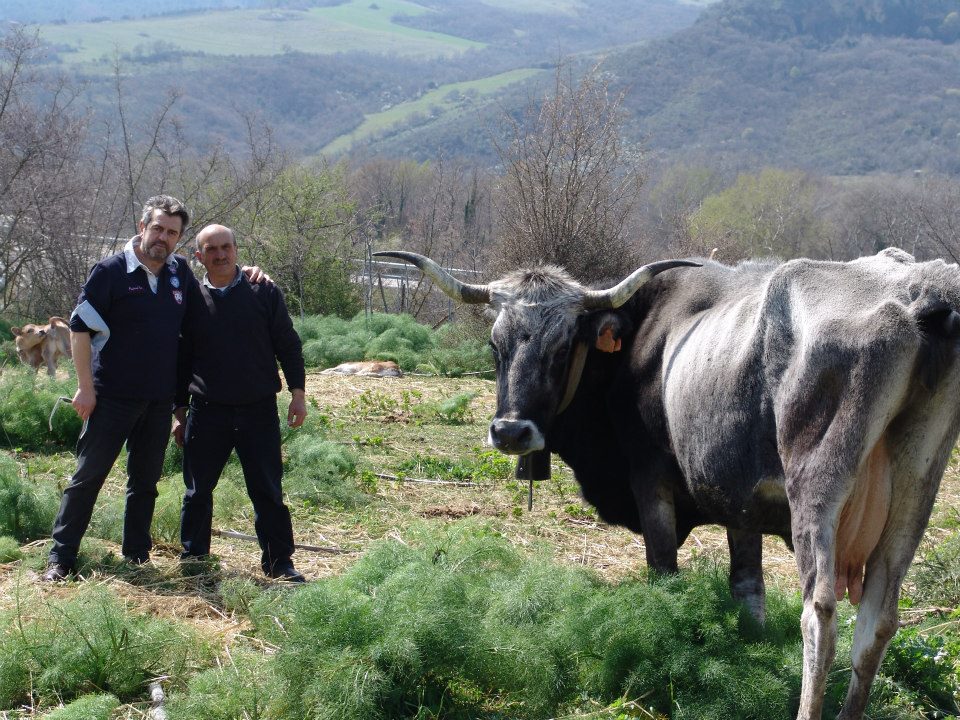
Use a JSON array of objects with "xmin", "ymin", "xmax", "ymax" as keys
[{"xmin": 322, "ymin": 68, "xmax": 544, "ymax": 155}]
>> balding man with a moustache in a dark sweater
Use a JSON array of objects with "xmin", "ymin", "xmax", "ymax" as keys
[{"xmin": 174, "ymin": 225, "xmax": 307, "ymax": 582}]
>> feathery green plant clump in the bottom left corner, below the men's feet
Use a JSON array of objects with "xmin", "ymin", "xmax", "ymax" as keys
[{"xmin": 0, "ymin": 586, "xmax": 212, "ymax": 708}]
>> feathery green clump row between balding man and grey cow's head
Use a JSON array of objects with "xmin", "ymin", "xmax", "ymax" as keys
[{"xmin": 294, "ymin": 313, "xmax": 493, "ymax": 376}]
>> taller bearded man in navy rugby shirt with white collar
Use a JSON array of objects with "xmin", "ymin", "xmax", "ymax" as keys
[{"xmin": 42, "ymin": 195, "xmax": 199, "ymax": 581}]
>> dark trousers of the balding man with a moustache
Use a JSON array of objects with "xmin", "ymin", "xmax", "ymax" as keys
[{"xmin": 180, "ymin": 397, "xmax": 293, "ymax": 573}]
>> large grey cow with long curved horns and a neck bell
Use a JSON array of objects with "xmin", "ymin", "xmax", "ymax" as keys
[{"xmin": 377, "ymin": 249, "xmax": 960, "ymax": 720}]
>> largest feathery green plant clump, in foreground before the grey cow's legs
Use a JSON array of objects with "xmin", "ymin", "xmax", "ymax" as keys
[{"xmin": 246, "ymin": 524, "xmax": 801, "ymax": 718}]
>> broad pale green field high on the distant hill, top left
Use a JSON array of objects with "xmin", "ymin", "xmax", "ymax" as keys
[{"xmin": 40, "ymin": 0, "xmax": 482, "ymax": 63}]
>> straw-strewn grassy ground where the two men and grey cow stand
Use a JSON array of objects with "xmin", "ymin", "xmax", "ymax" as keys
[{"xmin": 0, "ymin": 368, "xmax": 960, "ymax": 720}]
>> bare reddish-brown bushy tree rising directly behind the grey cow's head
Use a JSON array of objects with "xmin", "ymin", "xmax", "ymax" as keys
[{"xmin": 491, "ymin": 64, "xmax": 643, "ymax": 281}]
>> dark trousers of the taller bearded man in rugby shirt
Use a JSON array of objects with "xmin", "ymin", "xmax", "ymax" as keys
[{"xmin": 50, "ymin": 397, "xmax": 172, "ymax": 567}]
